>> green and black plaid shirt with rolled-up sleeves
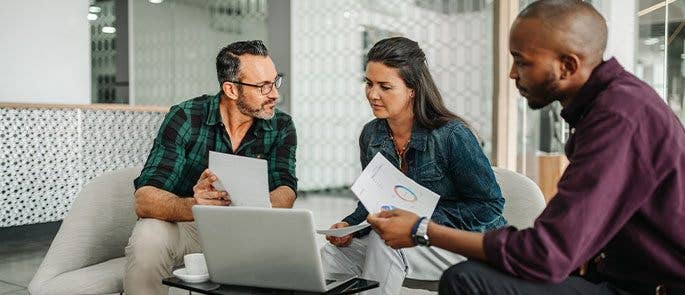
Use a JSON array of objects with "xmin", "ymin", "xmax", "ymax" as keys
[{"xmin": 133, "ymin": 94, "xmax": 297, "ymax": 197}]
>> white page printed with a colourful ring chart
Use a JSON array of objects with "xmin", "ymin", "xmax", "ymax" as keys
[{"xmin": 352, "ymin": 153, "xmax": 440, "ymax": 218}]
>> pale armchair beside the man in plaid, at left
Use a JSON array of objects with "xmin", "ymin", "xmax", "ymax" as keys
[{"xmin": 28, "ymin": 167, "xmax": 141, "ymax": 295}]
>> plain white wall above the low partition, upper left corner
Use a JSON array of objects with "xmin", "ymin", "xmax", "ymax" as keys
[{"xmin": 0, "ymin": 0, "xmax": 90, "ymax": 103}]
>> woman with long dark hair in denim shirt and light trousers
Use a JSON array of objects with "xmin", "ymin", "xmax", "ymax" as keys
[{"xmin": 321, "ymin": 37, "xmax": 506, "ymax": 294}]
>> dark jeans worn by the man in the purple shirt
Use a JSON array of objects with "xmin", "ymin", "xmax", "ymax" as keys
[{"xmin": 440, "ymin": 260, "xmax": 631, "ymax": 295}]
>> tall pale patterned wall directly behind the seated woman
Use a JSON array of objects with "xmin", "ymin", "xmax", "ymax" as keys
[{"xmin": 290, "ymin": 0, "xmax": 493, "ymax": 190}]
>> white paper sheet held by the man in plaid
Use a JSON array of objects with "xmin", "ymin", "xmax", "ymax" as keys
[{"xmin": 209, "ymin": 151, "xmax": 271, "ymax": 208}]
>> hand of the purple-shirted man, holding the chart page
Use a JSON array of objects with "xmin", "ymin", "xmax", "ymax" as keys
[{"xmin": 366, "ymin": 209, "xmax": 419, "ymax": 249}]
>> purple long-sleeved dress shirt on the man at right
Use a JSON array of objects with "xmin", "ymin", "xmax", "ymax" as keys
[{"xmin": 483, "ymin": 58, "xmax": 685, "ymax": 287}]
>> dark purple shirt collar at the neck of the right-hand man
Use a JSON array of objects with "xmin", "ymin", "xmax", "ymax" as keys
[{"xmin": 561, "ymin": 57, "xmax": 624, "ymax": 128}]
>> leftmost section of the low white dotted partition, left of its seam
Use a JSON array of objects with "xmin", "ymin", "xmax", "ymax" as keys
[{"xmin": 0, "ymin": 109, "xmax": 83, "ymax": 226}]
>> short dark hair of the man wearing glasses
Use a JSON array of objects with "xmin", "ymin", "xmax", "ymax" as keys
[{"xmin": 216, "ymin": 40, "xmax": 269, "ymax": 88}]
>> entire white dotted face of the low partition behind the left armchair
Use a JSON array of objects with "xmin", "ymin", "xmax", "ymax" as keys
[{"xmin": 0, "ymin": 108, "xmax": 164, "ymax": 227}]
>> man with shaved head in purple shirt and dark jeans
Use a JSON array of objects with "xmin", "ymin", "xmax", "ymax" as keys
[{"xmin": 368, "ymin": 0, "xmax": 685, "ymax": 295}]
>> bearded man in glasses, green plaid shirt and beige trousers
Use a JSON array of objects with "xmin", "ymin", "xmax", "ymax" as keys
[{"xmin": 124, "ymin": 41, "xmax": 297, "ymax": 294}]
